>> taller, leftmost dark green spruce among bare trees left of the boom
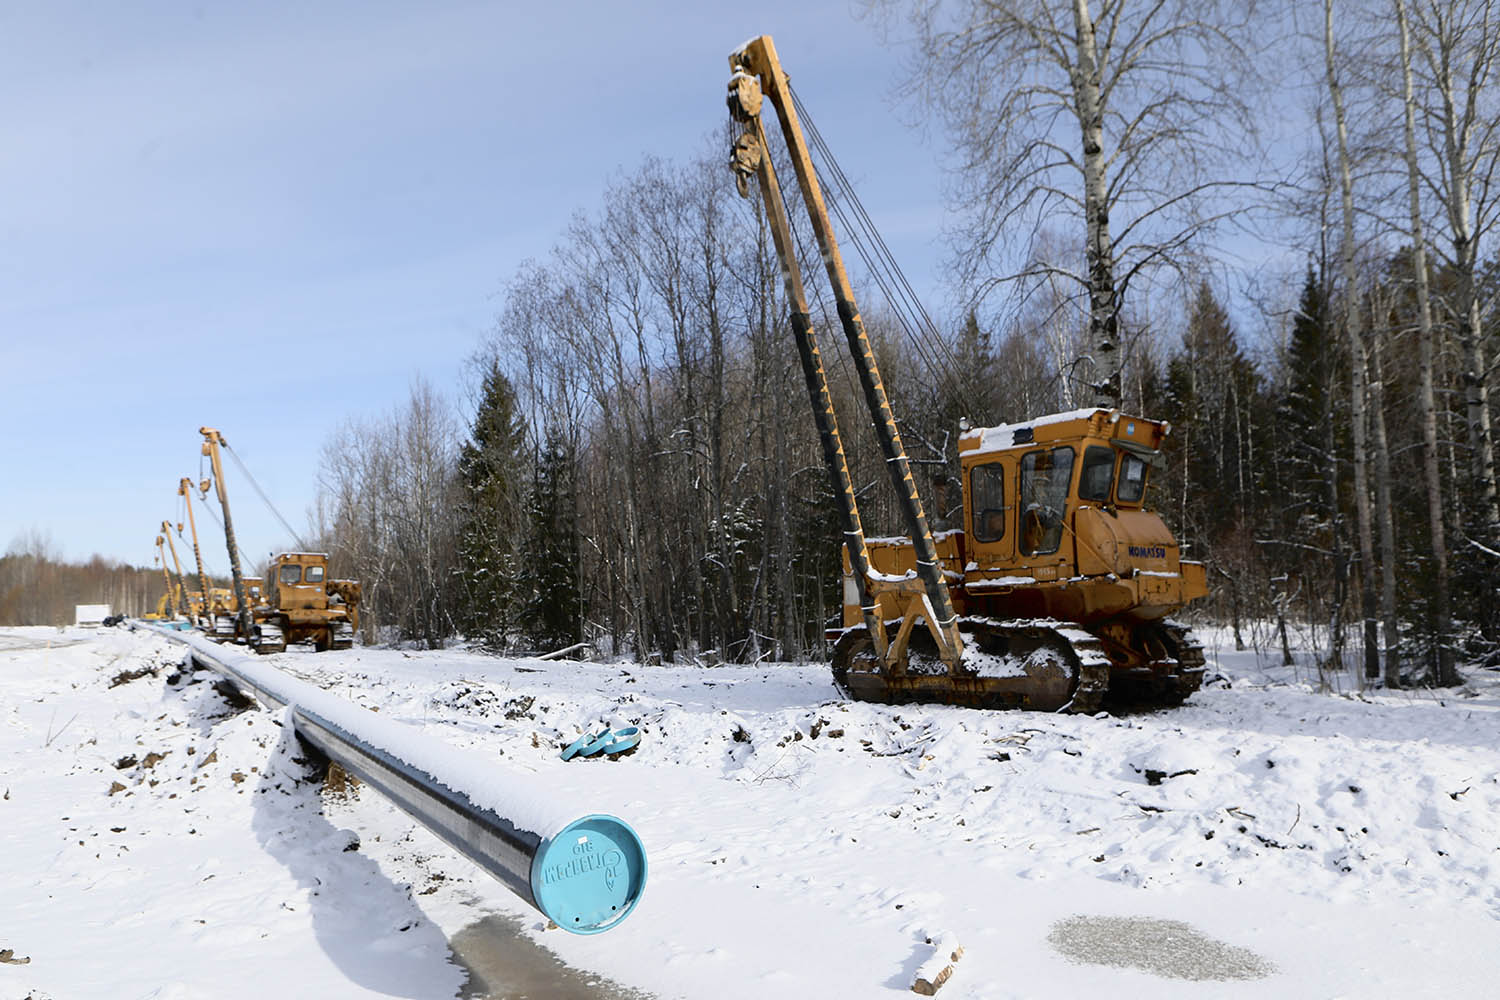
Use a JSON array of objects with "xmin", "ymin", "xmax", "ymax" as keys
[{"xmin": 458, "ymin": 363, "xmax": 527, "ymax": 646}]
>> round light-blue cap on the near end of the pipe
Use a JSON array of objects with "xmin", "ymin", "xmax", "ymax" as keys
[{"xmin": 531, "ymin": 814, "xmax": 647, "ymax": 934}]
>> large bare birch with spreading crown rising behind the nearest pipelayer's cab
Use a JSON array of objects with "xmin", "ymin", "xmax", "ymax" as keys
[{"xmin": 887, "ymin": 0, "xmax": 1254, "ymax": 406}]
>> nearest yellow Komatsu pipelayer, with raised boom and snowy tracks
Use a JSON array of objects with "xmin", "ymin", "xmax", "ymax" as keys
[{"xmin": 729, "ymin": 34, "xmax": 1208, "ymax": 712}]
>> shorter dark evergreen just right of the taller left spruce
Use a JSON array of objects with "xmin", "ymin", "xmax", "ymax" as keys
[{"xmin": 518, "ymin": 432, "xmax": 584, "ymax": 649}]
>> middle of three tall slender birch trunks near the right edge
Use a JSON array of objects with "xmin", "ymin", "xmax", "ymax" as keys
[{"xmin": 1388, "ymin": 0, "xmax": 1457, "ymax": 687}]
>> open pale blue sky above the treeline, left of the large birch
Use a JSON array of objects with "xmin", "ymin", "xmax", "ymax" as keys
[{"xmin": 0, "ymin": 0, "xmax": 944, "ymax": 571}]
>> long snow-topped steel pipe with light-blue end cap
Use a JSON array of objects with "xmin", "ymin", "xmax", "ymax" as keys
[{"xmin": 144, "ymin": 625, "xmax": 647, "ymax": 934}]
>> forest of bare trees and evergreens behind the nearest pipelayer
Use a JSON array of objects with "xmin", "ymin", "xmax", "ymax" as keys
[{"xmin": 11, "ymin": 0, "xmax": 1500, "ymax": 687}]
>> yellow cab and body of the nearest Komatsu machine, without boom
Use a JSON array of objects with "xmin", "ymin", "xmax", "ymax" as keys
[{"xmin": 836, "ymin": 408, "xmax": 1208, "ymax": 702}]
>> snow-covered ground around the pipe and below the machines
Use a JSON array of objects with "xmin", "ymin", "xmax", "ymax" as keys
[{"xmin": 0, "ymin": 620, "xmax": 1500, "ymax": 1000}]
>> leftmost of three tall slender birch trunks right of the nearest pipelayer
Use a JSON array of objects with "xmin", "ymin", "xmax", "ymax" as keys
[{"xmin": 1323, "ymin": 0, "xmax": 1380, "ymax": 679}]
